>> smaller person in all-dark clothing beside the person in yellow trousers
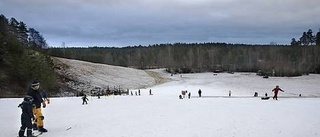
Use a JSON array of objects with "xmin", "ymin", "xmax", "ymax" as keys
[{"xmin": 18, "ymin": 96, "xmax": 34, "ymax": 137}]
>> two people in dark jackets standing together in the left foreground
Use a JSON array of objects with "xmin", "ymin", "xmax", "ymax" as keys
[{"xmin": 18, "ymin": 81, "xmax": 50, "ymax": 137}]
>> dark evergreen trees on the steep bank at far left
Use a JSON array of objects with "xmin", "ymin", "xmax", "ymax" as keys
[{"xmin": 0, "ymin": 15, "xmax": 56, "ymax": 97}]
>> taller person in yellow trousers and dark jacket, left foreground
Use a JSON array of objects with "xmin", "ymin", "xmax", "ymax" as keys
[{"xmin": 27, "ymin": 81, "xmax": 48, "ymax": 132}]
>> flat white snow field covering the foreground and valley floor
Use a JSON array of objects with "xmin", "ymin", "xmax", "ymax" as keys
[{"xmin": 0, "ymin": 59, "xmax": 320, "ymax": 137}]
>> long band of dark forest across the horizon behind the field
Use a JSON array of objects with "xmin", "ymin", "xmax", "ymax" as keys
[{"xmin": 48, "ymin": 43, "xmax": 320, "ymax": 76}]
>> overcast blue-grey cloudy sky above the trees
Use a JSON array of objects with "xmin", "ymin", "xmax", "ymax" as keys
[{"xmin": 0, "ymin": 0, "xmax": 320, "ymax": 47}]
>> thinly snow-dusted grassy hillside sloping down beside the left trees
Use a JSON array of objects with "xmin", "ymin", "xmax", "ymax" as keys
[{"xmin": 55, "ymin": 58, "xmax": 161, "ymax": 91}]
